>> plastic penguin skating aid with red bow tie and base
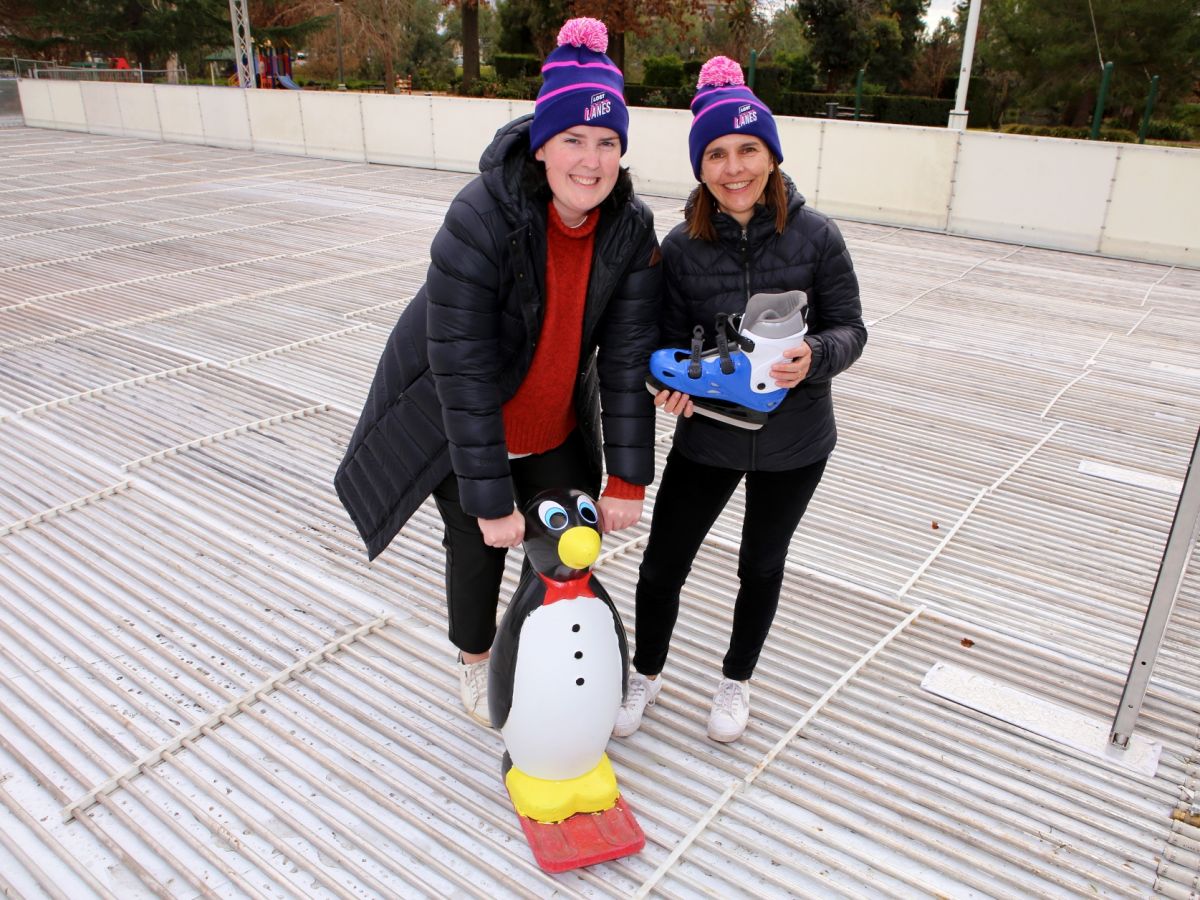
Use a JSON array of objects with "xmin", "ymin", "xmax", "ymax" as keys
[{"xmin": 487, "ymin": 490, "xmax": 646, "ymax": 871}]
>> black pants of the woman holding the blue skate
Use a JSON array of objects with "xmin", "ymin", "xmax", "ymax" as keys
[{"xmin": 634, "ymin": 450, "xmax": 827, "ymax": 682}]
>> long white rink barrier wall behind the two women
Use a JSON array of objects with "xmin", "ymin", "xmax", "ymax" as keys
[{"xmin": 11, "ymin": 79, "xmax": 1200, "ymax": 266}]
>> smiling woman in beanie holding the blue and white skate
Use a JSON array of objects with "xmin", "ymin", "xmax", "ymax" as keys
[{"xmin": 613, "ymin": 56, "xmax": 866, "ymax": 742}]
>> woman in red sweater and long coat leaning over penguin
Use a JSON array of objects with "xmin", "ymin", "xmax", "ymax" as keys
[{"xmin": 335, "ymin": 18, "xmax": 662, "ymax": 725}]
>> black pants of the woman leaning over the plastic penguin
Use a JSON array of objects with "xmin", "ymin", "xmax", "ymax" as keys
[{"xmin": 433, "ymin": 431, "xmax": 600, "ymax": 653}]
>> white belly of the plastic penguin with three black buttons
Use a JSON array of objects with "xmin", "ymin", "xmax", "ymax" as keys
[{"xmin": 500, "ymin": 596, "xmax": 624, "ymax": 781}]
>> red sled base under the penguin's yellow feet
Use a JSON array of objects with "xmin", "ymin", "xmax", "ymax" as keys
[{"xmin": 517, "ymin": 797, "xmax": 646, "ymax": 872}]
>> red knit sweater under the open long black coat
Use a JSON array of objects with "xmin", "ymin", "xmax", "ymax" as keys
[{"xmin": 502, "ymin": 203, "xmax": 646, "ymax": 500}]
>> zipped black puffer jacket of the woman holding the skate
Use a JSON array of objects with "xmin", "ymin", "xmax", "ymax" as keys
[{"xmin": 661, "ymin": 181, "xmax": 866, "ymax": 472}]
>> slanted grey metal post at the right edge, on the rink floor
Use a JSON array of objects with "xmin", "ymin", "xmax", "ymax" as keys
[{"xmin": 1109, "ymin": 427, "xmax": 1200, "ymax": 748}]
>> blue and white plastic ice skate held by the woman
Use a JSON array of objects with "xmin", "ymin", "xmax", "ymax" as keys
[{"xmin": 646, "ymin": 290, "xmax": 808, "ymax": 430}]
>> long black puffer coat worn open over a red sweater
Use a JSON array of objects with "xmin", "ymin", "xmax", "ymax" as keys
[{"xmin": 334, "ymin": 116, "xmax": 662, "ymax": 558}]
